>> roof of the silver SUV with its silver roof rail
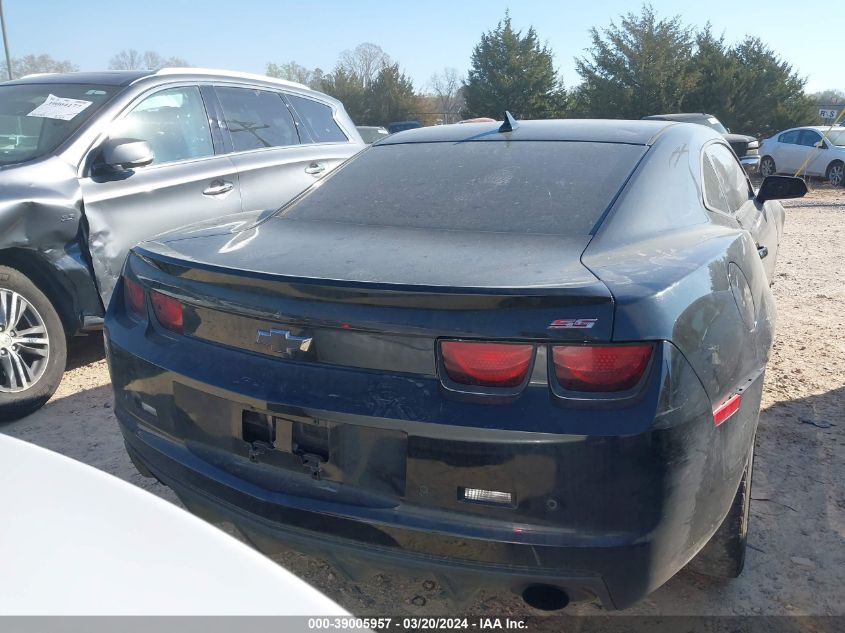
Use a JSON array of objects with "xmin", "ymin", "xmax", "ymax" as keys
[{"xmin": 0, "ymin": 68, "xmax": 312, "ymax": 91}]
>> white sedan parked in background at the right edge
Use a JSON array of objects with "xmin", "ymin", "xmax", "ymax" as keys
[{"xmin": 760, "ymin": 125, "xmax": 845, "ymax": 187}]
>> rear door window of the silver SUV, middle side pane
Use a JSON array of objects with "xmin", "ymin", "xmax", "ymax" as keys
[{"xmin": 214, "ymin": 86, "xmax": 299, "ymax": 152}]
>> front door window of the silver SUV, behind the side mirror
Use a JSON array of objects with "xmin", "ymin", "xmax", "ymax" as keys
[{"xmin": 109, "ymin": 86, "xmax": 214, "ymax": 165}]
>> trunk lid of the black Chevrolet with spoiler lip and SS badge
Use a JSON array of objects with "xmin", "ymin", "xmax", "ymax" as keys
[{"xmin": 136, "ymin": 218, "xmax": 613, "ymax": 350}]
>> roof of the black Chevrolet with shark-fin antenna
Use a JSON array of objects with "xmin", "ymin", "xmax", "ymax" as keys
[{"xmin": 375, "ymin": 119, "xmax": 679, "ymax": 145}]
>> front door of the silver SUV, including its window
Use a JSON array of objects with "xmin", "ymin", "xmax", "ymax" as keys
[{"xmin": 80, "ymin": 85, "xmax": 241, "ymax": 306}]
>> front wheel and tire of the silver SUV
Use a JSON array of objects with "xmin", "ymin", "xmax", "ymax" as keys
[{"xmin": 0, "ymin": 266, "xmax": 67, "ymax": 422}]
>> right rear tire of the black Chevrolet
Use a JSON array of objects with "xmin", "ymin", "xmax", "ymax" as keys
[{"xmin": 688, "ymin": 444, "xmax": 754, "ymax": 578}]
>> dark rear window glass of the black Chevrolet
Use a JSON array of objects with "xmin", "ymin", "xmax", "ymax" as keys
[{"xmin": 281, "ymin": 141, "xmax": 646, "ymax": 234}]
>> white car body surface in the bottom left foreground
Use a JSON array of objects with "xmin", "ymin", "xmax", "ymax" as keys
[{"xmin": 0, "ymin": 434, "xmax": 350, "ymax": 616}]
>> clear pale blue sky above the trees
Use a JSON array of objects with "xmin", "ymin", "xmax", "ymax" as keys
[{"xmin": 0, "ymin": 0, "xmax": 845, "ymax": 92}]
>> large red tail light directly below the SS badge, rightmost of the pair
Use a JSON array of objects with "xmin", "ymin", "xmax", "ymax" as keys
[{"xmin": 552, "ymin": 344, "xmax": 654, "ymax": 391}]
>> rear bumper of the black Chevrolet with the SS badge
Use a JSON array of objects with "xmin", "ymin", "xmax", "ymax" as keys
[{"xmin": 108, "ymin": 326, "xmax": 762, "ymax": 608}]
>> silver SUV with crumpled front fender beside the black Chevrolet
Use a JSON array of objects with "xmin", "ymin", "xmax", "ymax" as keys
[{"xmin": 0, "ymin": 68, "xmax": 364, "ymax": 420}]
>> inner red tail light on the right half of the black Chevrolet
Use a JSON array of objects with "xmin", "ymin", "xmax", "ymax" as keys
[{"xmin": 440, "ymin": 341, "xmax": 534, "ymax": 387}]
